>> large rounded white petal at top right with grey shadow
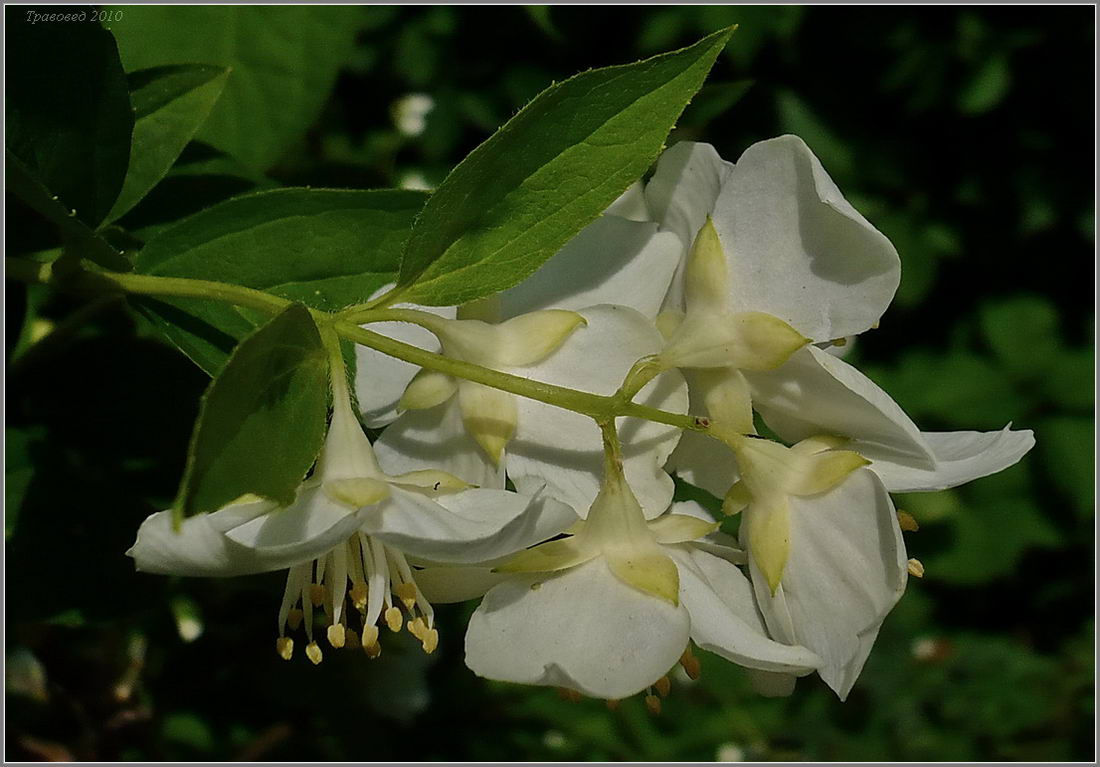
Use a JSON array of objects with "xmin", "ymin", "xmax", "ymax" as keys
[{"xmin": 713, "ymin": 135, "xmax": 901, "ymax": 341}]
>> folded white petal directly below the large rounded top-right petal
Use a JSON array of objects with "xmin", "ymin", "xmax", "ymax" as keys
[{"xmin": 745, "ymin": 347, "xmax": 935, "ymax": 469}]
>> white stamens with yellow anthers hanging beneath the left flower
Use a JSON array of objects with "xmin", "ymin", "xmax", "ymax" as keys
[{"xmin": 275, "ymin": 533, "xmax": 439, "ymax": 664}]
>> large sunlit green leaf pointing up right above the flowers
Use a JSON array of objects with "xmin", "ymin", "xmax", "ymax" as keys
[{"xmin": 399, "ymin": 30, "xmax": 733, "ymax": 305}]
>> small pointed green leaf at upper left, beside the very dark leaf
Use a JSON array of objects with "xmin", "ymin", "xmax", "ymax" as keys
[{"xmin": 107, "ymin": 64, "xmax": 229, "ymax": 221}]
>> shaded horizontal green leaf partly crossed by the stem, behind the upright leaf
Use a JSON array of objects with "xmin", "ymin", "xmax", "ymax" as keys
[{"xmin": 134, "ymin": 188, "xmax": 426, "ymax": 375}]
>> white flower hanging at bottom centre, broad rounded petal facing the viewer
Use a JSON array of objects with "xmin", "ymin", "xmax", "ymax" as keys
[{"xmin": 466, "ymin": 451, "xmax": 821, "ymax": 699}]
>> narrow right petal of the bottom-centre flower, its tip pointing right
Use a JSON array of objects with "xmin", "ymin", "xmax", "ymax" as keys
[{"xmin": 664, "ymin": 546, "xmax": 821, "ymax": 675}]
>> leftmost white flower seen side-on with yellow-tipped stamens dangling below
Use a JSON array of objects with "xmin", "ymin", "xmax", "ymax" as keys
[{"xmin": 127, "ymin": 385, "xmax": 576, "ymax": 664}]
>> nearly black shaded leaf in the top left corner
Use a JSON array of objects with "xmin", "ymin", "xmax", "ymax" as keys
[{"xmin": 4, "ymin": 6, "xmax": 134, "ymax": 228}]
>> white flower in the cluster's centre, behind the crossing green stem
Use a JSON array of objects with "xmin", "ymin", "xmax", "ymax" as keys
[{"xmin": 356, "ymin": 196, "xmax": 688, "ymax": 516}]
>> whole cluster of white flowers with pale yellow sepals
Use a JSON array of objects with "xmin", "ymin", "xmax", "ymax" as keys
[{"xmin": 130, "ymin": 136, "xmax": 1034, "ymax": 709}]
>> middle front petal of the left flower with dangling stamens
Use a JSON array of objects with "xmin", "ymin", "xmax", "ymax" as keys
[{"xmin": 226, "ymin": 484, "xmax": 373, "ymax": 561}]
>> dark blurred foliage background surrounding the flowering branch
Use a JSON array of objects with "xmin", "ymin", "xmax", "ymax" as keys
[{"xmin": 4, "ymin": 6, "xmax": 1095, "ymax": 761}]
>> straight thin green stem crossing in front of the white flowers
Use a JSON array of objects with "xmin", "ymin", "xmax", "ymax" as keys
[{"xmin": 332, "ymin": 319, "xmax": 710, "ymax": 431}]
